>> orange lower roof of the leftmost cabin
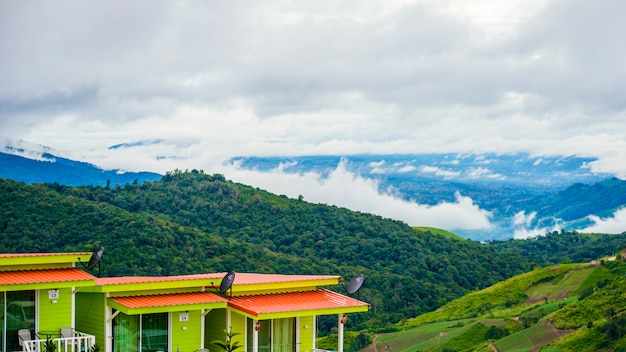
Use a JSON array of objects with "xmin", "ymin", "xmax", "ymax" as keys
[{"xmin": 0, "ymin": 268, "xmax": 95, "ymax": 285}]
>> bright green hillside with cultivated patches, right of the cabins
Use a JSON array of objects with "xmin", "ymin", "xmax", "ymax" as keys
[{"xmin": 375, "ymin": 261, "xmax": 626, "ymax": 351}]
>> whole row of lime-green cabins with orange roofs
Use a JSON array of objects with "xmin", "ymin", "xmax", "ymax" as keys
[{"xmin": 0, "ymin": 253, "xmax": 369, "ymax": 352}]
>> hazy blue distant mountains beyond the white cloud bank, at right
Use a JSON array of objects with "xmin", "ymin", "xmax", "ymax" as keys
[{"xmin": 231, "ymin": 153, "xmax": 626, "ymax": 241}]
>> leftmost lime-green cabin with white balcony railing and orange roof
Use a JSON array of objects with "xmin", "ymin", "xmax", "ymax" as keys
[{"xmin": 0, "ymin": 252, "xmax": 96, "ymax": 352}]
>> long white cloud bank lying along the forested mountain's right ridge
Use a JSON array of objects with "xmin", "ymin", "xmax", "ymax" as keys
[{"xmin": 224, "ymin": 161, "xmax": 493, "ymax": 230}]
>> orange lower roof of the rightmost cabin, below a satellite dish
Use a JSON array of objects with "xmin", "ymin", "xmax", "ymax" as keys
[{"xmin": 228, "ymin": 289, "xmax": 369, "ymax": 317}]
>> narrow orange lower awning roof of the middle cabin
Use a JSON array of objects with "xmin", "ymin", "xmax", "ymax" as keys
[{"xmin": 109, "ymin": 292, "xmax": 226, "ymax": 309}]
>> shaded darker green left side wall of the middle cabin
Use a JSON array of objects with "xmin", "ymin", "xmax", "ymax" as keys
[{"xmin": 76, "ymin": 292, "xmax": 106, "ymax": 351}]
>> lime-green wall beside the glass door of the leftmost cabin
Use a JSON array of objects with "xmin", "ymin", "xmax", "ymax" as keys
[{"xmin": 37, "ymin": 288, "xmax": 72, "ymax": 337}]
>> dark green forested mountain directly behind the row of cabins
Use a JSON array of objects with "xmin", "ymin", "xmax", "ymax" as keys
[{"xmin": 0, "ymin": 170, "xmax": 624, "ymax": 327}]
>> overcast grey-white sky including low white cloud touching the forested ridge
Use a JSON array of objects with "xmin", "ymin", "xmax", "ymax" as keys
[{"xmin": 0, "ymin": 0, "xmax": 626, "ymax": 236}]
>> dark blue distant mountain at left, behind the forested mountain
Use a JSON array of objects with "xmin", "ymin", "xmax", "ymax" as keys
[{"xmin": 0, "ymin": 152, "xmax": 161, "ymax": 186}]
